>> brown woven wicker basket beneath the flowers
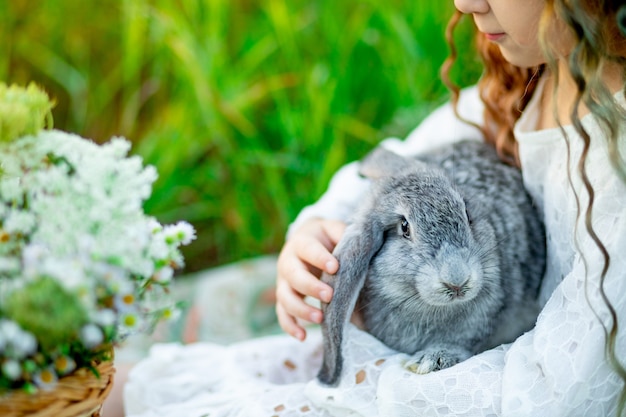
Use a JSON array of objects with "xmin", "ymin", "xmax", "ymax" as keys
[{"xmin": 0, "ymin": 360, "xmax": 115, "ymax": 417}]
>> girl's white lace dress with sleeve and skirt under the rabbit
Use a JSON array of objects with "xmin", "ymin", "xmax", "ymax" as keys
[{"xmin": 125, "ymin": 79, "xmax": 626, "ymax": 417}]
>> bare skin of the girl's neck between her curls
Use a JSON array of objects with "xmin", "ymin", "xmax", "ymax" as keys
[{"xmin": 537, "ymin": 59, "xmax": 625, "ymax": 130}]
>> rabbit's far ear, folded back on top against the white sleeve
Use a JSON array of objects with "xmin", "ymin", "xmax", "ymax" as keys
[{"xmin": 359, "ymin": 146, "xmax": 424, "ymax": 180}]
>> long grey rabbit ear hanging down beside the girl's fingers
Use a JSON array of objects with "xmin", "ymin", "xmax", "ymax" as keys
[{"xmin": 317, "ymin": 216, "xmax": 384, "ymax": 386}]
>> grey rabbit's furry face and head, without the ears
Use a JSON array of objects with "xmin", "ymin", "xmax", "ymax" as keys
[{"xmin": 366, "ymin": 168, "xmax": 495, "ymax": 308}]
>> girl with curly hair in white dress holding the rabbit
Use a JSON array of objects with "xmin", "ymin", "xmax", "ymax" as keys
[{"xmin": 126, "ymin": 0, "xmax": 626, "ymax": 416}]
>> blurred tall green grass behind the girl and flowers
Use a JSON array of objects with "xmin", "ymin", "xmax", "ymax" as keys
[{"xmin": 0, "ymin": 0, "xmax": 479, "ymax": 272}]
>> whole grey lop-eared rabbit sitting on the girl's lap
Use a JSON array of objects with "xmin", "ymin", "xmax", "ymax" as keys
[{"xmin": 318, "ymin": 141, "xmax": 546, "ymax": 386}]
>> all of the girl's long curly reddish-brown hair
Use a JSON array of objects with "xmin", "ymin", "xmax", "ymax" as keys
[{"xmin": 441, "ymin": 0, "xmax": 626, "ymax": 415}]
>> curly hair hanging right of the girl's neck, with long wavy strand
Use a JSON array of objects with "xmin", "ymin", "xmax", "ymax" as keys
[{"xmin": 540, "ymin": 0, "xmax": 626, "ymax": 416}]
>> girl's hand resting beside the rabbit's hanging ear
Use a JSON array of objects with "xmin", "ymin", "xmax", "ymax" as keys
[{"xmin": 276, "ymin": 219, "xmax": 346, "ymax": 340}]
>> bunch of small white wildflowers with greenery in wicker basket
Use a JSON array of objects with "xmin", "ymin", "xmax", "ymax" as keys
[{"xmin": 0, "ymin": 84, "xmax": 195, "ymax": 416}]
